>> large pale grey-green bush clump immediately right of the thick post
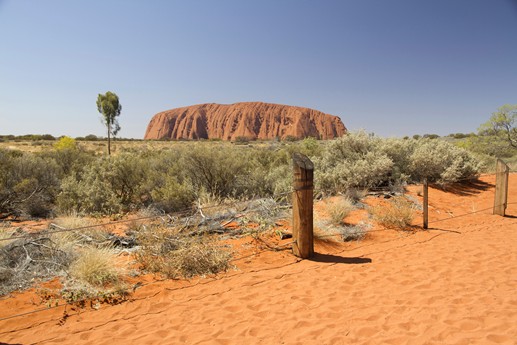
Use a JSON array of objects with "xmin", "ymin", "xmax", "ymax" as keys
[{"xmin": 315, "ymin": 131, "xmax": 481, "ymax": 193}]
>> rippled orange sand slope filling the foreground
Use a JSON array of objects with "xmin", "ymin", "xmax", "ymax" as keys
[{"xmin": 0, "ymin": 175, "xmax": 517, "ymax": 345}]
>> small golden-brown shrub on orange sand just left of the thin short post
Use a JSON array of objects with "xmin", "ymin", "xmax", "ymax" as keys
[{"xmin": 370, "ymin": 196, "xmax": 415, "ymax": 229}]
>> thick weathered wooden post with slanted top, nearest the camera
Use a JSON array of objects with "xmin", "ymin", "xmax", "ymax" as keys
[{"xmin": 293, "ymin": 153, "xmax": 314, "ymax": 259}]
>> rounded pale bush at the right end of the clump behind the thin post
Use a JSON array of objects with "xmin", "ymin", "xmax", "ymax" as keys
[{"xmin": 410, "ymin": 140, "xmax": 480, "ymax": 183}]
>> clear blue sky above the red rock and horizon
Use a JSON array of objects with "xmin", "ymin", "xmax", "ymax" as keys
[{"xmin": 0, "ymin": 0, "xmax": 517, "ymax": 138}]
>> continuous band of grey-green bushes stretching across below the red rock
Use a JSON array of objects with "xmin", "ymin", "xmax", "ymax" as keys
[{"xmin": 0, "ymin": 132, "xmax": 488, "ymax": 217}]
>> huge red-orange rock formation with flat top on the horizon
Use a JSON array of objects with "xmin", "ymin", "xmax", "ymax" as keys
[{"xmin": 144, "ymin": 102, "xmax": 347, "ymax": 140}]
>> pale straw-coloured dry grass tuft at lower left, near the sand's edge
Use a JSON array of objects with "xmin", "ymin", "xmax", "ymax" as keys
[{"xmin": 69, "ymin": 247, "xmax": 121, "ymax": 286}]
